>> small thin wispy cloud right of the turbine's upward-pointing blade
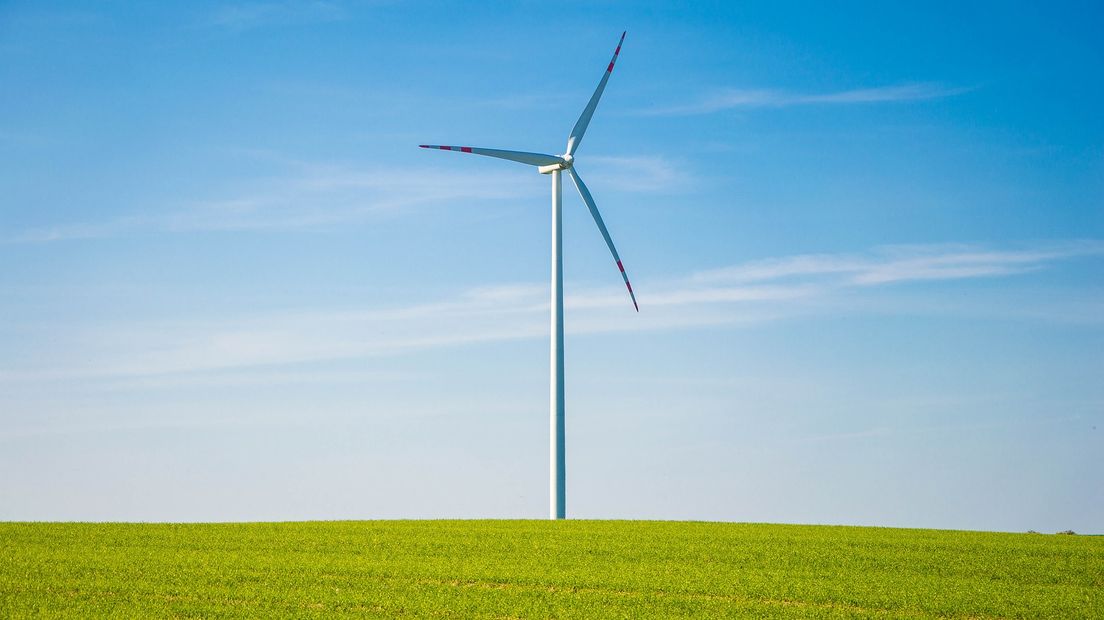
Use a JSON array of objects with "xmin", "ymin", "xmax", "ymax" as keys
[{"xmin": 641, "ymin": 83, "xmax": 969, "ymax": 116}]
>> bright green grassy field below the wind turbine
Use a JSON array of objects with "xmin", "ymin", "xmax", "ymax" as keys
[{"xmin": 0, "ymin": 521, "xmax": 1104, "ymax": 618}]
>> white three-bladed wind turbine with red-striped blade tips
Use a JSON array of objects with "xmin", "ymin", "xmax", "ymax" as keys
[{"xmin": 420, "ymin": 32, "xmax": 640, "ymax": 520}]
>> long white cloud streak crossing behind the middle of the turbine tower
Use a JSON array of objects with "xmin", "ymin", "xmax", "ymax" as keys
[{"xmin": 0, "ymin": 239, "xmax": 1104, "ymax": 386}]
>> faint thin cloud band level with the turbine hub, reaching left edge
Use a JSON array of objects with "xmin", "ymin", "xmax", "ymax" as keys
[{"xmin": 0, "ymin": 156, "xmax": 689, "ymax": 244}]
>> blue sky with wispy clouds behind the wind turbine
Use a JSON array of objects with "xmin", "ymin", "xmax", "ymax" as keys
[{"xmin": 0, "ymin": 1, "xmax": 1104, "ymax": 532}]
